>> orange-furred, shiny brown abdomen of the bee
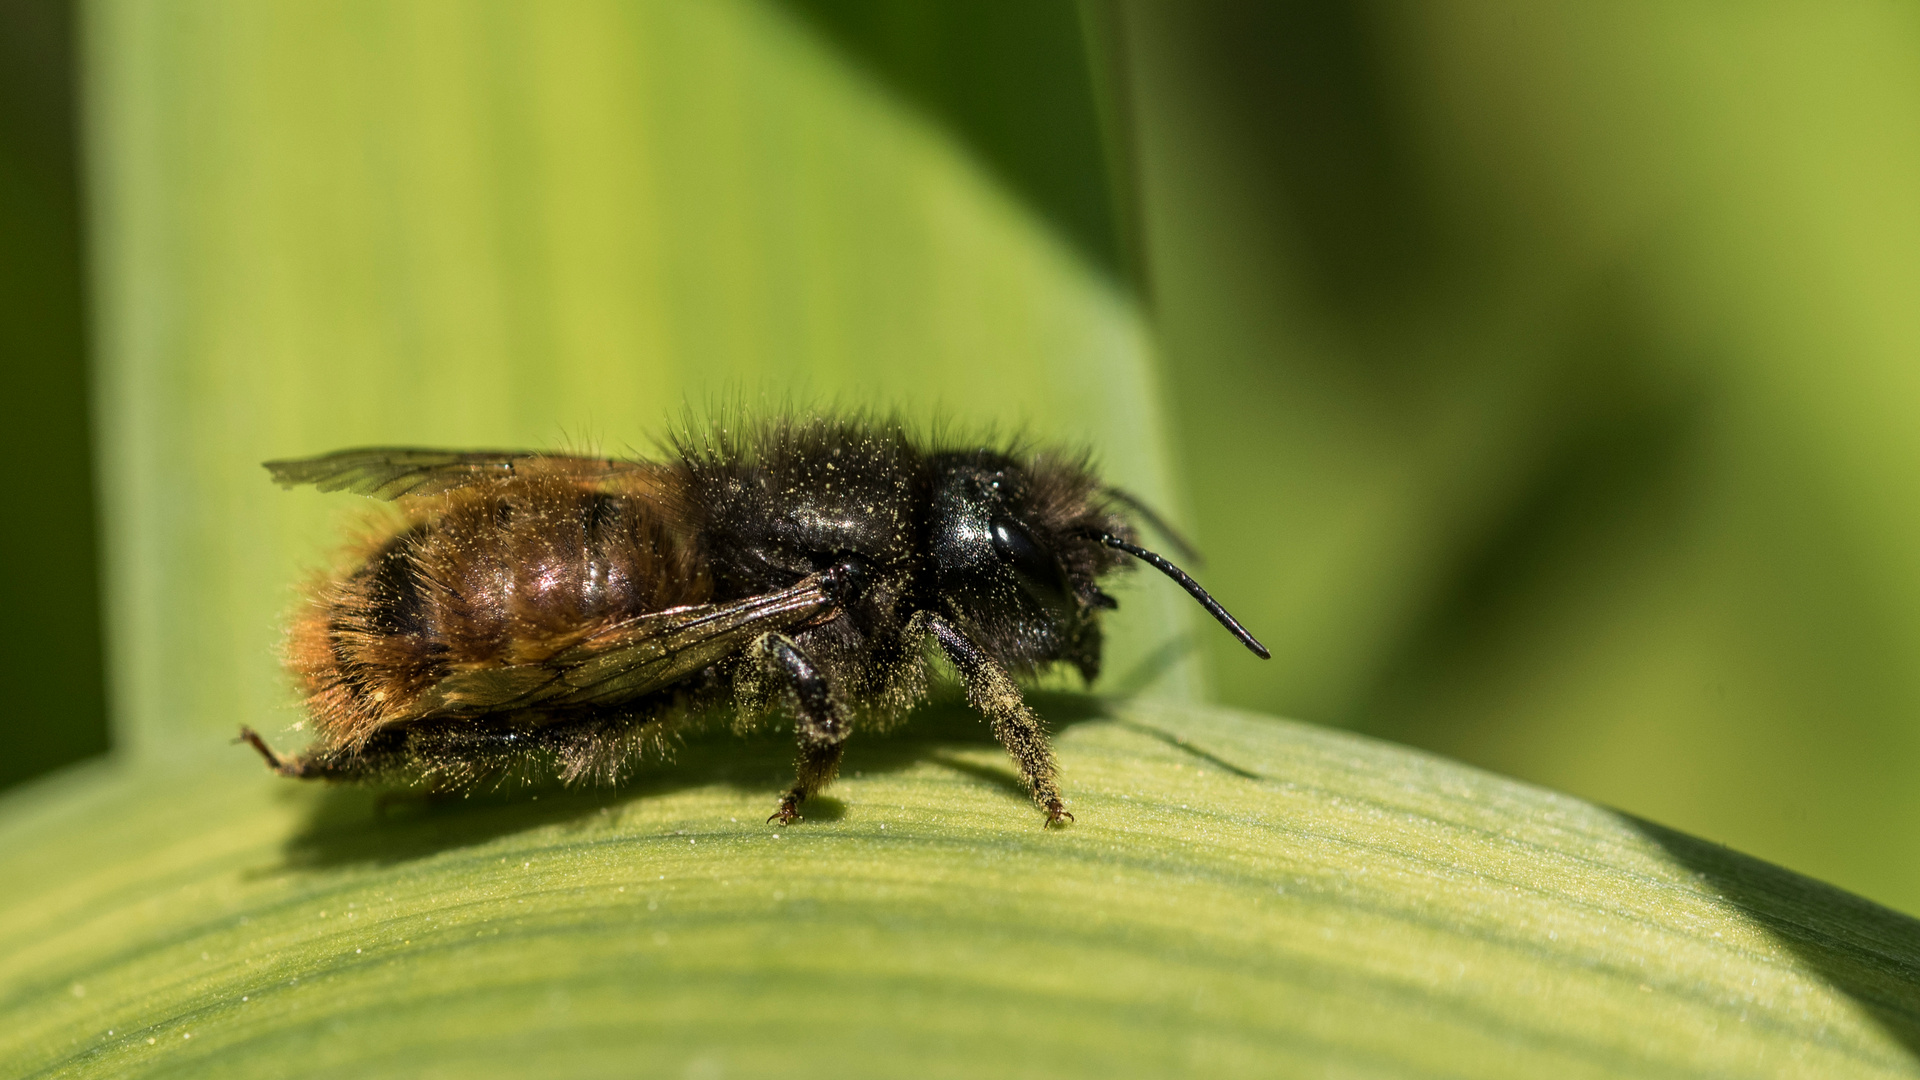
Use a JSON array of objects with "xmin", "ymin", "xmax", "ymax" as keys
[{"xmin": 288, "ymin": 475, "xmax": 712, "ymax": 748}]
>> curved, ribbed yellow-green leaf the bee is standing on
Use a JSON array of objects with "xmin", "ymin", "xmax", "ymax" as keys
[{"xmin": 11, "ymin": 696, "xmax": 1920, "ymax": 1076}]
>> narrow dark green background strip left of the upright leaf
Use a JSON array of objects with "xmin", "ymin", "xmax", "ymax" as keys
[{"xmin": 0, "ymin": 0, "xmax": 108, "ymax": 788}]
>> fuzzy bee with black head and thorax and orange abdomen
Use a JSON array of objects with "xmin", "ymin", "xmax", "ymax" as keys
[{"xmin": 240, "ymin": 415, "xmax": 1269, "ymax": 824}]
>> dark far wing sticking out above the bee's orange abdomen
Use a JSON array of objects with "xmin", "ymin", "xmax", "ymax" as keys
[{"xmin": 265, "ymin": 446, "xmax": 645, "ymax": 500}]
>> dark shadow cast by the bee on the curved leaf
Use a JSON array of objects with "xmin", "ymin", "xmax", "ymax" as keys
[{"xmin": 275, "ymin": 692, "xmax": 1108, "ymax": 872}]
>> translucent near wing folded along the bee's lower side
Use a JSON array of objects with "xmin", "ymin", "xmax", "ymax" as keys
[{"xmin": 397, "ymin": 575, "xmax": 833, "ymax": 723}]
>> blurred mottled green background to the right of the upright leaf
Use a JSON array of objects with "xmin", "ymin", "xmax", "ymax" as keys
[{"xmin": 1125, "ymin": 2, "xmax": 1920, "ymax": 911}]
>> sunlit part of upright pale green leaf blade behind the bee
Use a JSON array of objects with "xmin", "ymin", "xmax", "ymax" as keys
[{"xmin": 88, "ymin": 0, "xmax": 1192, "ymax": 753}]
